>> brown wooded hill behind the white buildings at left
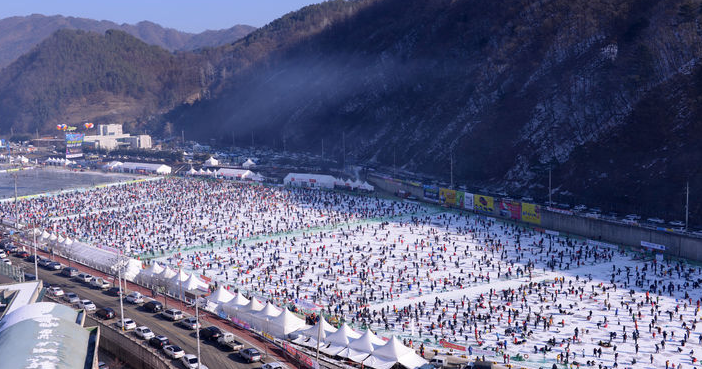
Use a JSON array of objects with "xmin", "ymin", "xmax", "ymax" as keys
[{"xmin": 0, "ymin": 29, "xmax": 207, "ymax": 133}]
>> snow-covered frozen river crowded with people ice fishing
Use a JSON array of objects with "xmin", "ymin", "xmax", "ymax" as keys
[{"xmin": 6, "ymin": 178, "xmax": 702, "ymax": 368}]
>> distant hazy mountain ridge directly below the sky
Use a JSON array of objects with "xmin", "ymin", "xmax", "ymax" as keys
[{"xmin": 0, "ymin": 14, "xmax": 256, "ymax": 69}]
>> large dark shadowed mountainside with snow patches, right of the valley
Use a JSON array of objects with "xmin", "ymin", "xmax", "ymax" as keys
[{"xmin": 166, "ymin": 0, "xmax": 702, "ymax": 217}]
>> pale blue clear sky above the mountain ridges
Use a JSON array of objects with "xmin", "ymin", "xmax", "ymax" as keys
[{"xmin": 0, "ymin": 0, "xmax": 322, "ymax": 33}]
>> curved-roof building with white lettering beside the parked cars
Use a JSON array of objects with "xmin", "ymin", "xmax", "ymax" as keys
[{"xmin": 0, "ymin": 281, "xmax": 100, "ymax": 369}]
